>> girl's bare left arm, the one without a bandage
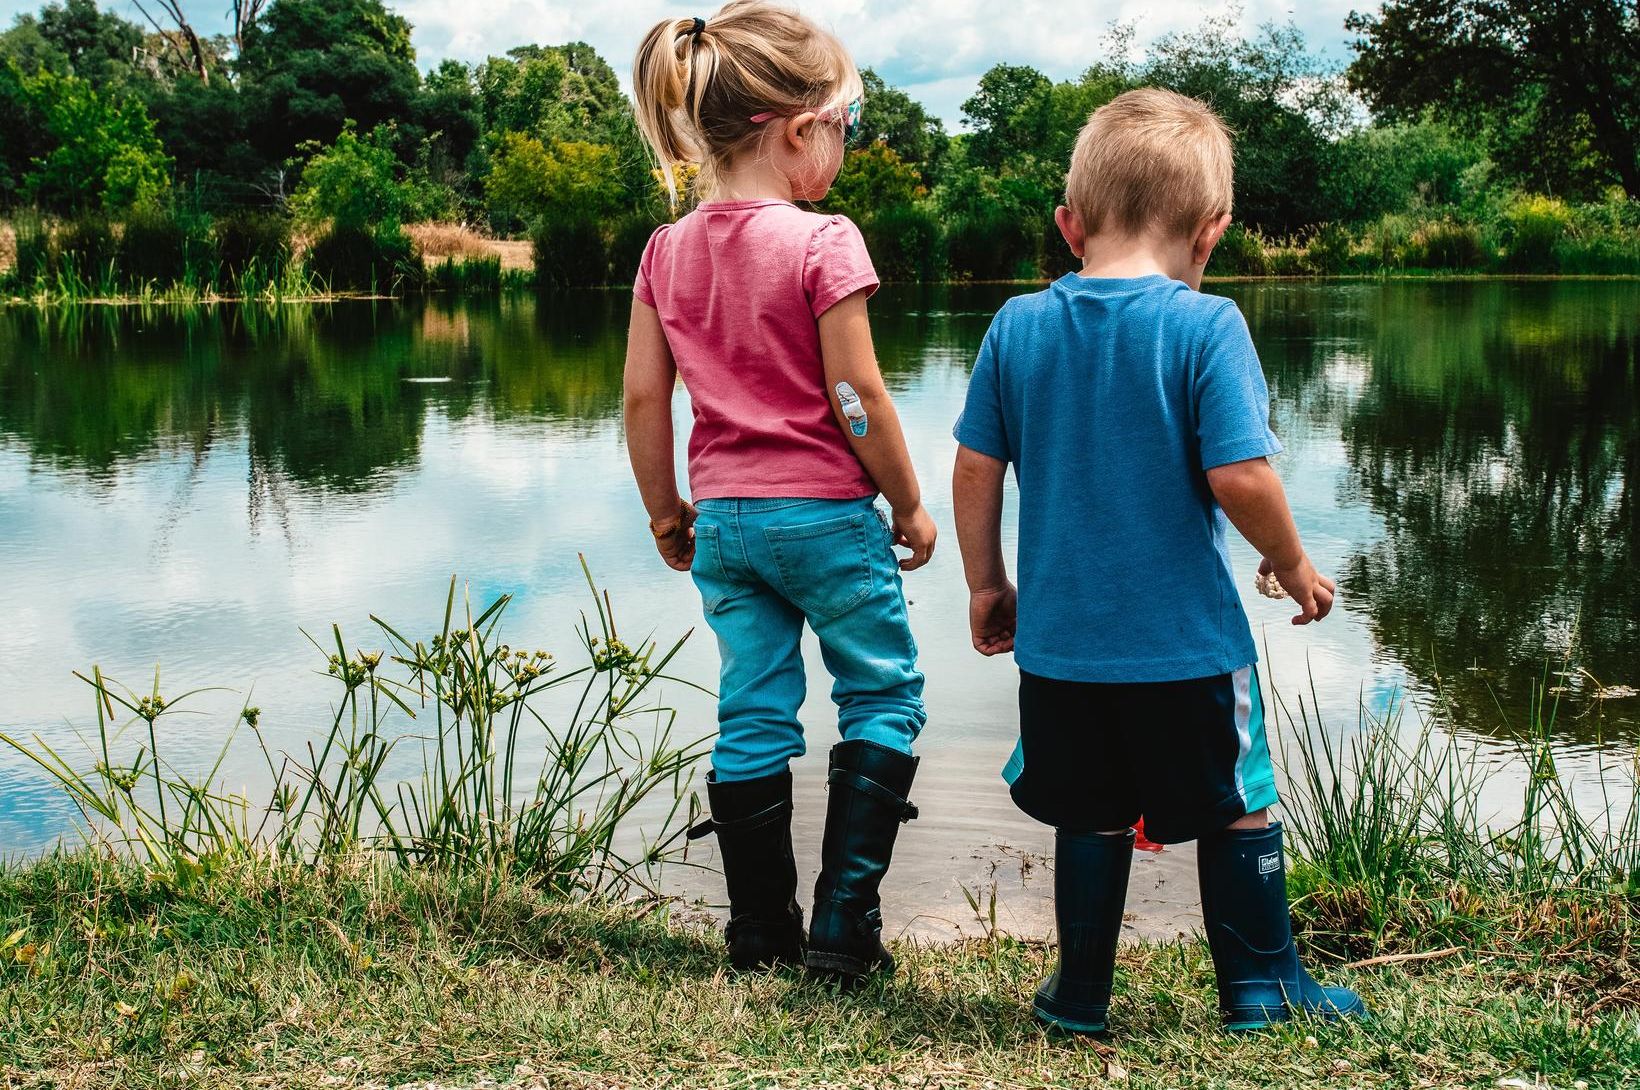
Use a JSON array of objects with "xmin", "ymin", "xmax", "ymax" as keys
[{"xmin": 622, "ymin": 300, "xmax": 695, "ymax": 572}]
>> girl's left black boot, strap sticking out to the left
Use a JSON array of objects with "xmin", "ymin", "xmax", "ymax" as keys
[{"xmin": 689, "ymin": 769, "xmax": 804, "ymax": 970}]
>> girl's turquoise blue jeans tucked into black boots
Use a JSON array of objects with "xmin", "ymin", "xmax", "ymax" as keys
[{"xmin": 694, "ymin": 498, "xmax": 927, "ymax": 782}]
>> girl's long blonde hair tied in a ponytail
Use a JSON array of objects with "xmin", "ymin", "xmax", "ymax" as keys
[{"xmin": 631, "ymin": 0, "xmax": 863, "ymax": 203}]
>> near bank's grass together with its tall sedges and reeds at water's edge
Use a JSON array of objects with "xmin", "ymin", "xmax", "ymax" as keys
[{"xmin": 0, "ymin": 577, "xmax": 1640, "ymax": 1090}]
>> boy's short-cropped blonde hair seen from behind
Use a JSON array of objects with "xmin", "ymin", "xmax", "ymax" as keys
[{"xmin": 1064, "ymin": 87, "xmax": 1235, "ymax": 236}]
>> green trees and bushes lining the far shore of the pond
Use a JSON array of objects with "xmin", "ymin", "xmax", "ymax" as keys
[{"xmin": 0, "ymin": 0, "xmax": 1640, "ymax": 303}]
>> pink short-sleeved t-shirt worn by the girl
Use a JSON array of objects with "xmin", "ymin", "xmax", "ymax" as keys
[{"xmin": 633, "ymin": 200, "xmax": 877, "ymax": 500}]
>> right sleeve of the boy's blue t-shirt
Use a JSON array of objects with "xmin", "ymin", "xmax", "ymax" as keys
[{"xmin": 1192, "ymin": 302, "xmax": 1281, "ymax": 469}]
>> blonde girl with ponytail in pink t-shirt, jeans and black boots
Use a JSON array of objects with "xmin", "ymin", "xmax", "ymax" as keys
[{"xmin": 625, "ymin": 0, "xmax": 935, "ymax": 979}]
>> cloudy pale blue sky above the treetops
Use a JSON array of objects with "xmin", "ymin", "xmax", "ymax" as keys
[{"xmin": 0, "ymin": 0, "xmax": 1376, "ymax": 129}]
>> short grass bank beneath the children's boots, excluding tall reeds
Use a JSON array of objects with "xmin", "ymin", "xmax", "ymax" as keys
[{"xmin": 0, "ymin": 854, "xmax": 1640, "ymax": 1088}]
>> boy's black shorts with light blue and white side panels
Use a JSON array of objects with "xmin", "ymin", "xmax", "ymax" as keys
[{"xmin": 1004, "ymin": 665, "xmax": 1276, "ymax": 844}]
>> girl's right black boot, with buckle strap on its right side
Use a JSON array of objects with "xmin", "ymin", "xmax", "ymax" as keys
[{"xmin": 804, "ymin": 741, "xmax": 917, "ymax": 980}]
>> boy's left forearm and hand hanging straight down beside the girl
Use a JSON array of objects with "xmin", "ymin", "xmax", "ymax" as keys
[{"xmin": 951, "ymin": 446, "xmax": 1018, "ymax": 656}]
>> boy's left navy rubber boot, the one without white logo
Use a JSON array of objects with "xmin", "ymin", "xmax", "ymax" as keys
[{"xmin": 1032, "ymin": 829, "xmax": 1135, "ymax": 1033}]
